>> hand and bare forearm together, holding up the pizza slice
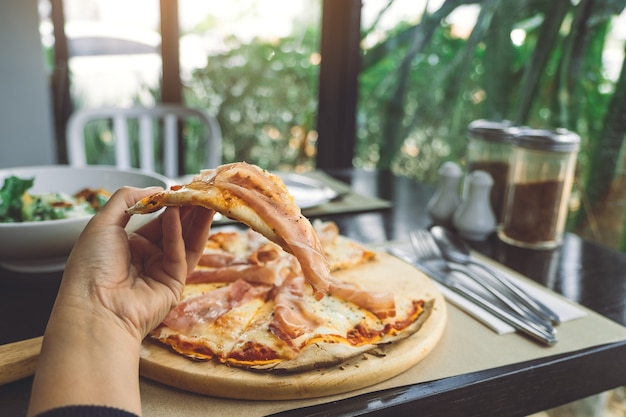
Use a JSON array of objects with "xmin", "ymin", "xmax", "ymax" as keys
[{"xmin": 28, "ymin": 188, "xmax": 214, "ymax": 415}]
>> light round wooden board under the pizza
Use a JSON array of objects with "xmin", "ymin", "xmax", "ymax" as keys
[{"xmin": 140, "ymin": 253, "xmax": 447, "ymax": 400}]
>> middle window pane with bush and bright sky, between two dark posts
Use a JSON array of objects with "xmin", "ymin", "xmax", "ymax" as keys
[{"xmin": 180, "ymin": 0, "xmax": 321, "ymax": 170}]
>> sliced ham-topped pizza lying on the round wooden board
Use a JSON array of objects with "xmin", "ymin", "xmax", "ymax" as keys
[{"xmin": 150, "ymin": 222, "xmax": 433, "ymax": 372}]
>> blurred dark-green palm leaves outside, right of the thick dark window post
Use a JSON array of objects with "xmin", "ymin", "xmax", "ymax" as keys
[{"xmin": 355, "ymin": 0, "xmax": 626, "ymax": 249}]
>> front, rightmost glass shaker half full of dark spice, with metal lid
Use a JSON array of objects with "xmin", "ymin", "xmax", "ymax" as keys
[{"xmin": 498, "ymin": 128, "xmax": 580, "ymax": 249}]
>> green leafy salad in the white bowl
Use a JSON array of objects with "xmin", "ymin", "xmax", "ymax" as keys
[{"xmin": 0, "ymin": 176, "xmax": 110, "ymax": 223}]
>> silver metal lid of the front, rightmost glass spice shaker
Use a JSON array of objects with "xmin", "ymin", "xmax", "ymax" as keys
[{"xmin": 513, "ymin": 128, "xmax": 580, "ymax": 152}]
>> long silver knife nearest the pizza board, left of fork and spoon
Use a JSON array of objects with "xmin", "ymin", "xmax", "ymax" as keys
[{"xmin": 387, "ymin": 248, "xmax": 558, "ymax": 346}]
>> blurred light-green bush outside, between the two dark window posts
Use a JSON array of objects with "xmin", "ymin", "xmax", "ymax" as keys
[{"xmin": 186, "ymin": 27, "xmax": 319, "ymax": 169}]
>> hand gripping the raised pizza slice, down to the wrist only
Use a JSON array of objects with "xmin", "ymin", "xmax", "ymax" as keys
[{"xmin": 58, "ymin": 188, "xmax": 214, "ymax": 340}]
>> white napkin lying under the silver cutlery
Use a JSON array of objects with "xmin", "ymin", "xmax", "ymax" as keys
[{"xmin": 384, "ymin": 242, "xmax": 587, "ymax": 334}]
